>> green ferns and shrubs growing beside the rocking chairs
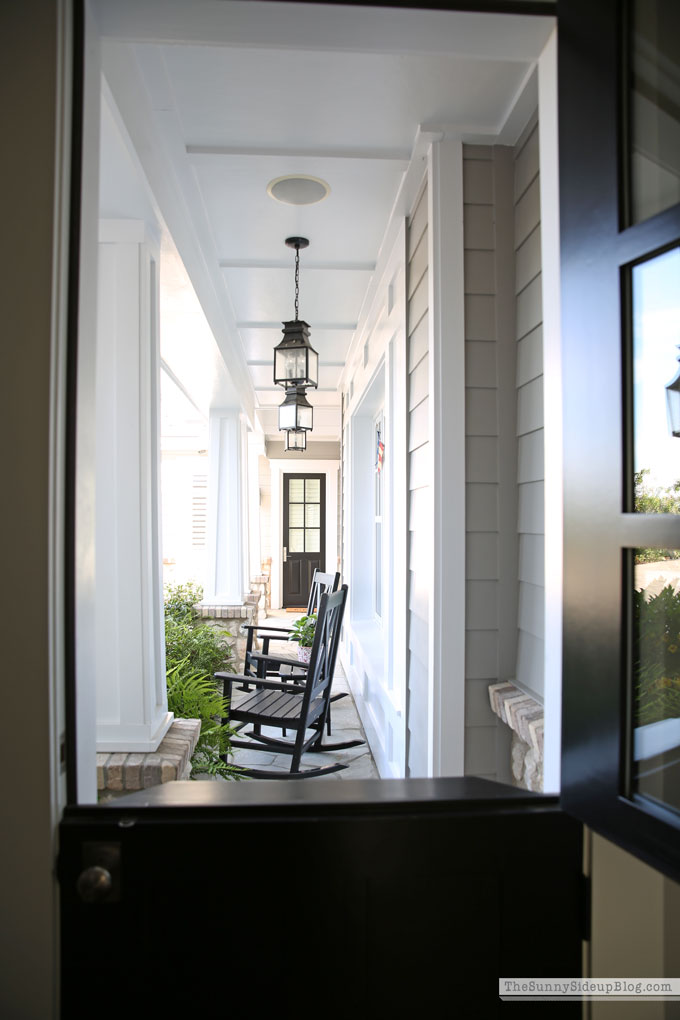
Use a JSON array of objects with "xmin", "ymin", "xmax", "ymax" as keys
[{"xmin": 165, "ymin": 581, "xmax": 241, "ymax": 779}]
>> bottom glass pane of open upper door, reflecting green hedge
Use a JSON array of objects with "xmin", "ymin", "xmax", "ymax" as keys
[{"xmin": 632, "ymin": 549, "xmax": 680, "ymax": 811}]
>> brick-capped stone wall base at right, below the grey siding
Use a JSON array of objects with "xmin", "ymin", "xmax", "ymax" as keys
[{"xmin": 488, "ymin": 680, "xmax": 543, "ymax": 793}]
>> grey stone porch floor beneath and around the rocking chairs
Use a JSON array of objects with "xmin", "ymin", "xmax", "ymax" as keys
[{"xmin": 215, "ymin": 609, "xmax": 380, "ymax": 782}]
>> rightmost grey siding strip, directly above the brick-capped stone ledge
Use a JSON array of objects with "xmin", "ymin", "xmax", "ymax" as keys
[{"xmin": 514, "ymin": 118, "xmax": 544, "ymax": 698}]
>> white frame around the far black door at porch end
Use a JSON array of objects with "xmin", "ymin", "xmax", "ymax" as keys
[{"xmin": 269, "ymin": 458, "xmax": 341, "ymax": 609}]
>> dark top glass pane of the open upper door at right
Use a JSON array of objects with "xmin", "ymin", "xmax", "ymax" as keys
[{"xmin": 628, "ymin": 0, "xmax": 680, "ymax": 223}]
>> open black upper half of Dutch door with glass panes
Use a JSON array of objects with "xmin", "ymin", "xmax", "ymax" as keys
[{"xmin": 559, "ymin": 0, "xmax": 680, "ymax": 879}]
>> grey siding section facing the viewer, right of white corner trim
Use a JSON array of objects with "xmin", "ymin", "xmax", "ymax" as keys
[{"xmin": 463, "ymin": 146, "xmax": 517, "ymax": 778}]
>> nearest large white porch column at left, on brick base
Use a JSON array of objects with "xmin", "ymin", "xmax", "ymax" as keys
[{"xmin": 96, "ymin": 220, "xmax": 172, "ymax": 752}]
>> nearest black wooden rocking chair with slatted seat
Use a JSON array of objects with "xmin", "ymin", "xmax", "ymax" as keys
[{"xmin": 215, "ymin": 584, "xmax": 364, "ymax": 779}]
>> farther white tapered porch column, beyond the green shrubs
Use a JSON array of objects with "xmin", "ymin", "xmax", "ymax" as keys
[{"xmin": 204, "ymin": 408, "xmax": 248, "ymax": 606}]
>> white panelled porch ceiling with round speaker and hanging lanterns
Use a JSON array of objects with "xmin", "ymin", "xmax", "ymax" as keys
[{"xmin": 97, "ymin": 0, "xmax": 553, "ymax": 439}]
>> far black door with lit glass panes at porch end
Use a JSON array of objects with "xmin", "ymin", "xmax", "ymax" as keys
[{"xmin": 283, "ymin": 474, "xmax": 326, "ymax": 609}]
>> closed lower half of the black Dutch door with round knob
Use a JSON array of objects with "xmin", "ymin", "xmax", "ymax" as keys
[{"xmin": 58, "ymin": 4, "xmax": 586, "ymax": 1020}]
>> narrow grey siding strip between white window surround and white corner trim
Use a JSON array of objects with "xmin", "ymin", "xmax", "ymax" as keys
[{"xmin": 407, "ymin": 181, "xmax": 431, "ymax": 776}]
